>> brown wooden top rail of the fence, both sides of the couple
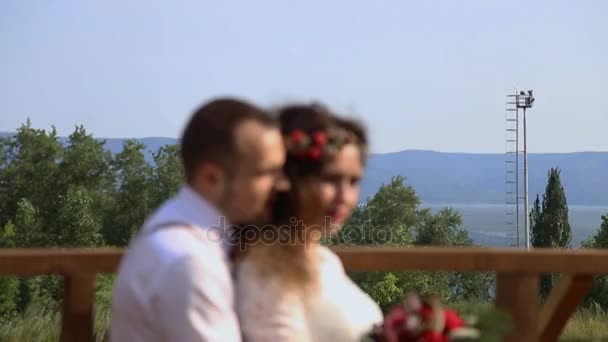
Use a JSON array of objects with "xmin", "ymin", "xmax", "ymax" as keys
[{"xmin": 0, "ymin": 247, "xmax": 608, "ymax": 276}]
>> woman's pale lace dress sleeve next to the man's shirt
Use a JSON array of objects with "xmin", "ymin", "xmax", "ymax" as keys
[{"xmin": 235, "ymin": 261, "xmax": 312, "ymax": 342}]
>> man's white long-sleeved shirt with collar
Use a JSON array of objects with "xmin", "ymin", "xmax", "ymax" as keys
[{"xmin": 110, "ymin": 187, "xmax": 241, "ymax": 342}]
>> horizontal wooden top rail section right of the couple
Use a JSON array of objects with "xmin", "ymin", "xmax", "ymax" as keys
[{"xmin": 332, "ymin": 247, "xmax": 608, "ymax": 274}]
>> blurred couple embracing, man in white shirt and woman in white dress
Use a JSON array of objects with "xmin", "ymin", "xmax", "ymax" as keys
[{"xmin": 111, "ymin": 98, "xmax": 382, "ymax": 342}]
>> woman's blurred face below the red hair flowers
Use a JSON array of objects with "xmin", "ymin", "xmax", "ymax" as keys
[{"xmin": 301, "ymin": 144, "xmax": 363, "ymax": 235}]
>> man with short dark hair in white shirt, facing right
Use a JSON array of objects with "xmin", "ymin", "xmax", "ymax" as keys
[{"xmin": 111, "ymin": 99, "xmax": 288, "ymax": 342}]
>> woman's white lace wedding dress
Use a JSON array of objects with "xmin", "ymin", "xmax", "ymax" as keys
[{"xmin": 236, "ymin": 246, "xmax": 383, "ymax": 342}]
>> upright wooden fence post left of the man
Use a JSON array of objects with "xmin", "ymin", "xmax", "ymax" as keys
[{"xmin": 61, "ymin": 273, "xmax": 95, "ymax": 342}]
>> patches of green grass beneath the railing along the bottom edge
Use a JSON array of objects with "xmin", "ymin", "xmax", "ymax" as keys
[{"xmin": 0, "ymin": 301, "xmax": 608, "ymax": 342}]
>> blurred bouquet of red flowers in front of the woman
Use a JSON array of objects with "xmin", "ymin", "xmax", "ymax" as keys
[{"xmin": 366, "ymin": 293, "xmax": 511, "ymax": 342}]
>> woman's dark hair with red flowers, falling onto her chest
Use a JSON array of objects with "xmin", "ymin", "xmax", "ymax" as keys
[{"xmin": 232, "ymin": 104, "xmax": 368, "ymax": 286}]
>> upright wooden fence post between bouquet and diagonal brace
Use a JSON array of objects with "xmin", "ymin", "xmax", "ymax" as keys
[{"xmin": 496, "ymin": 273, "xmax": 540, "ymax": 342}]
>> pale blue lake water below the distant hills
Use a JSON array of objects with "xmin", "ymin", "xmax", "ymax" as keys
[{"xmin": 421, "ymin": 203, "xmax": 608, "ymax": 248}]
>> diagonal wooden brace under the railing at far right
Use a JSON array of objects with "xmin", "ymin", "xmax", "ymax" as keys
[{"xmin": 539, "ymin": 274, "xmax": 593, "ymax": 341}]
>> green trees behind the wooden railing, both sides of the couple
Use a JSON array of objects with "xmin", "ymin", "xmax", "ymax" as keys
[{"xmin": 0, "ymin": 121, "xmax": 608, "ymax": 320}]
